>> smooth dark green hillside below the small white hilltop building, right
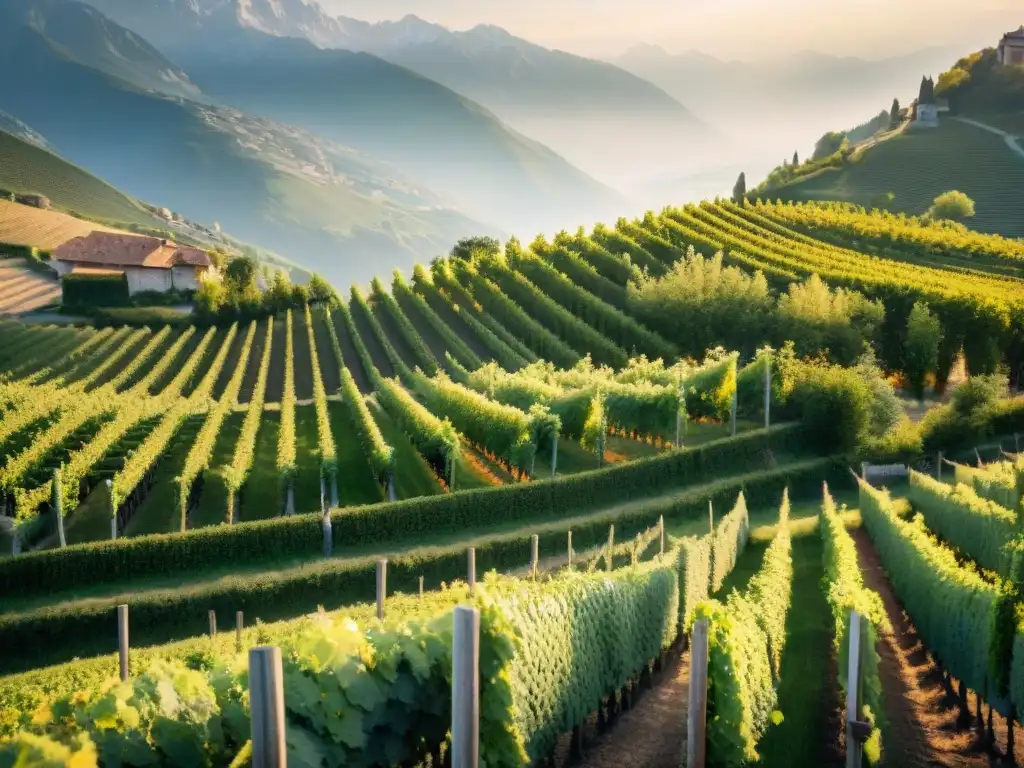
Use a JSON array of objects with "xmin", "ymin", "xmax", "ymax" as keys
[{"xmin": 770, "ymin": 119, "xmax": 1024, "ymax": 238}]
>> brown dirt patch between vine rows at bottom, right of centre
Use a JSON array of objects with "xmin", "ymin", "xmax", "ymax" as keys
[{"xmin": 581, "ymin": 653, "xmax": 690, "ymax": 768}]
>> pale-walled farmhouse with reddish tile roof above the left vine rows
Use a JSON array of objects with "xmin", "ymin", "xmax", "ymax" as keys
[{"xmin": 50, "ymin": 231, "xmax": 218, "ymax": 294}]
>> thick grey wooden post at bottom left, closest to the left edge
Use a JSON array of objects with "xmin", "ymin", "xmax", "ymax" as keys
[{"xmin": 249, "ymin": 645, "xmax": 288, "ymax": 768}]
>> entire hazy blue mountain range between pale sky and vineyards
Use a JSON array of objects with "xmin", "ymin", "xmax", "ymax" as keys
[{"xmin": 0, "ymin": 0, "xmax": 1007, "ymax": 283}]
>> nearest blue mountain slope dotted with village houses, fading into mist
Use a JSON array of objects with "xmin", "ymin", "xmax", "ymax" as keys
[{"xmin": 0, "ymin": 0, "xmax": 638, "ymax": 282}]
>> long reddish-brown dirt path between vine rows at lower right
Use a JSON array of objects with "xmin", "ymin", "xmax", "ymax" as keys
[{"xmin": 851, "ymin": 528, "xmax": 990, "ymax": 768}]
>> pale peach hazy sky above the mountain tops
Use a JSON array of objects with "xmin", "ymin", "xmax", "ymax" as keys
[{"xmin": 319, "ymin": 0, "xmax": 1024, "ymax": 59}]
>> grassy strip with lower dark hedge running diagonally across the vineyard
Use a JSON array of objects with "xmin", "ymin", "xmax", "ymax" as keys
[{"xmin": 0, "ymin": 460, "xmax": 830, "ymax": 670}]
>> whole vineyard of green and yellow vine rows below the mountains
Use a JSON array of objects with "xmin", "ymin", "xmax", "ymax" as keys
[{"xmin": 0, "ymin": 196, "xmax": 1024, "ymax": 766}]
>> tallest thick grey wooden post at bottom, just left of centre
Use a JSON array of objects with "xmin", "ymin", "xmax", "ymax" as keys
[{"xmin": 452, "ymin": 605, "xmax": 480, "ymax": 768}]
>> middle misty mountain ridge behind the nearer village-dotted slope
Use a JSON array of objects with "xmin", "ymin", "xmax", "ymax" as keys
[{"xmin": 77, "ymin": 0, "xmax": 720, "ymax": 189}]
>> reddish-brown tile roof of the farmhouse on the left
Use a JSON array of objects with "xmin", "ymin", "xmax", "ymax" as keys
[{"xmin": 53, "ymin": 231, "xmax": 212, "ymax": 269}]
